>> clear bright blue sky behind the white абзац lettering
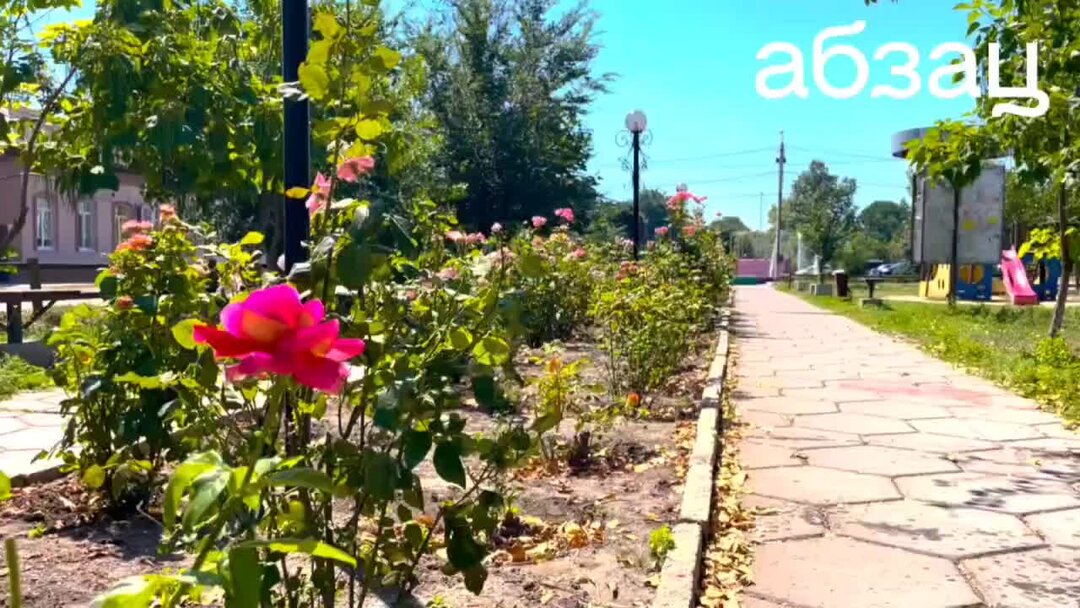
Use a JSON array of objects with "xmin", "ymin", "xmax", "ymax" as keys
[{"xmin": 35, "ymin": 0, "xmax": 972, "ymax": 228}]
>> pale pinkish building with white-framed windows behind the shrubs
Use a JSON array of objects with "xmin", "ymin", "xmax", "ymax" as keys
[{"xmin": 0, "ymin": 107, "xmax": 153, "ymax": 282}]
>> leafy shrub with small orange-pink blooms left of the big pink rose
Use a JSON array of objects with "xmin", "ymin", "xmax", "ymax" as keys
[{"xmin": 49, "ymin": 214, "xmax": 248, "ymax": 506}]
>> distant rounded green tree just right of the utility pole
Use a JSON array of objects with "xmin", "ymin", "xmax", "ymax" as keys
[{"xmin": 784, "ymin": 161, "xmax": 855, "ymax": 278}]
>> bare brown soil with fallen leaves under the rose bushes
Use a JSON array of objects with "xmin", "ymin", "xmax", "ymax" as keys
[{"xmin": 0, "ymin": 336, "xmax": 713, "ymax": 608}]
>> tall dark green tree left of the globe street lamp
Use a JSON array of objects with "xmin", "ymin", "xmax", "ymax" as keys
[{"xmin": 415, "ymin": 0, "xmax": 607, "ymax": 229}]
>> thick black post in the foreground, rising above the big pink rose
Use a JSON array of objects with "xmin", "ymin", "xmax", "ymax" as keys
[{"xmin": 281, "ymin": 0, "xmax": 311, "ymax": 272}]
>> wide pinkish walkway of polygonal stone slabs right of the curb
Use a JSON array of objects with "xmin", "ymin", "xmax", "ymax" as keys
[{"xmin": 732, "ymin": 286, "xmax": 1080, "ymax": 608}]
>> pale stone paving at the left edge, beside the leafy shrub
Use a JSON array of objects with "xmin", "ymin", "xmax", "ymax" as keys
[{"xmin": 0, "ymin": 390, "xmax": 64, "ymax": 477}]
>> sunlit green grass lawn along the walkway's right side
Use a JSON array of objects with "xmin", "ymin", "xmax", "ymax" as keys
[{"xmin": 789, "ymin": 292, "xmax": 1080, "ymax": 422}]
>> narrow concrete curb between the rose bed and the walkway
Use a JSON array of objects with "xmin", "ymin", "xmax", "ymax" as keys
[{"xmin": 652, "ymin": 302, "xmax": 732, "ymax": 608}]
